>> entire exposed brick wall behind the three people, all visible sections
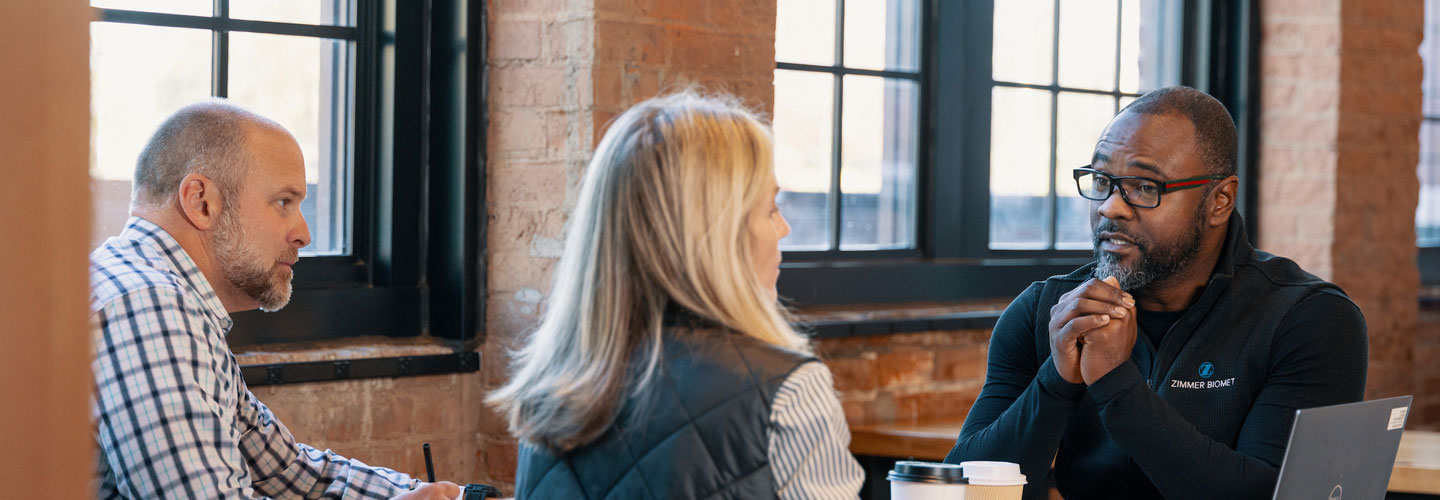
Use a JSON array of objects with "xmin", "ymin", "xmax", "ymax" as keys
[{"xmin": 236, "ymin": 0, "xmax": 1440, "ymax": 493}]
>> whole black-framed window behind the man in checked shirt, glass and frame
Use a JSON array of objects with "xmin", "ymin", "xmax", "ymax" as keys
[{"xmin": 91, "ymin": 0, "xmax": 484, "ymax": 344}]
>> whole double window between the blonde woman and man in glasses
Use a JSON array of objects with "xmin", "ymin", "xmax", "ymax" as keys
[{"xmin": 773, "ymin": 0, "xmax": 1257, "ymax": 304}]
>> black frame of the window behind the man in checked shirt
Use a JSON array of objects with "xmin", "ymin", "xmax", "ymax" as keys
[{"xmin": 92, "ymin": 0, "xmax": 485, "ymax": 350}]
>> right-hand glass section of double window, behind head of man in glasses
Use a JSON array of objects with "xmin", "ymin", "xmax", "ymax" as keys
[{"xmin": 989, "ymin": 0, "xmax": 1179, "ymax": 249}]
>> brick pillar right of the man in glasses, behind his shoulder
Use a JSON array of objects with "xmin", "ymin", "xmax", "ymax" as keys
[{"xmin": 1260, "ymin": 0, "xmax": 1422, "ymax": 412}]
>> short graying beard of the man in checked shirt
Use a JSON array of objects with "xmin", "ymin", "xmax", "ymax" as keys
[{"xmin": 215, "ymin": 209, "xmax": 291, "ymax": 313}]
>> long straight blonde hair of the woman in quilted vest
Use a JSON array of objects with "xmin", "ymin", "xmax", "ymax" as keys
[{"xmin": 487, "ymin": 92, "xmax": 809, "ymax": 452}]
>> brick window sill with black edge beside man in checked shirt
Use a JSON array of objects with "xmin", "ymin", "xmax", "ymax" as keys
[{"xmin": 235, "ymin": 336, "xmax": 480, "ymax": 386}]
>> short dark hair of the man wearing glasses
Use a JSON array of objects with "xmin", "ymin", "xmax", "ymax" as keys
[{"xmin": 1120, "ymin": 85, "xmax": 1236, "ymax": 176}]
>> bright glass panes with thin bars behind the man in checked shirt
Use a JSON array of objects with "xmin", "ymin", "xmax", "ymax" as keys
[{"xmin": 91, "ymin": 0, "xmax": 359, "ymax": 256}]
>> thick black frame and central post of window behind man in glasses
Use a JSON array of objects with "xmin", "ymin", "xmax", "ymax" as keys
[{"xmin": 778, "ymin": 0, "xmax": 1259, "ymax": 307}]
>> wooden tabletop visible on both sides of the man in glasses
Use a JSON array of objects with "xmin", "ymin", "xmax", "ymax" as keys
[{"xmin": 850, "ymin": 421, "xmax": 1440, "ymax": 496}]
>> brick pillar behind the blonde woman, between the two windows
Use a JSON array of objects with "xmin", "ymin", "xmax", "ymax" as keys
[{"xmin": 471, "ymin": 0, "xmax": 775, "ymax": 491}]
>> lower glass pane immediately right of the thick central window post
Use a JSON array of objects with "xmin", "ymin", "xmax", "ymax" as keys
[{"xmin": 989, "ymin": 86, "xmax": 1051, "ymax": 249}]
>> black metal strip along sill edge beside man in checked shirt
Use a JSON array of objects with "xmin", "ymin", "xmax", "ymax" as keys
[{"xmin": 240, "ymin": 353, "xmax": 480, "ymax": 388}]
